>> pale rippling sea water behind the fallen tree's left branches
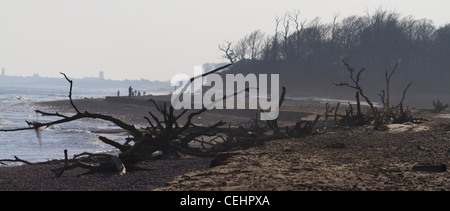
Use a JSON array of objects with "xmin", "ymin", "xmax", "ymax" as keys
[{"xmin": 0, "ymin": 87, "xmax": 126, "ymax": 165}]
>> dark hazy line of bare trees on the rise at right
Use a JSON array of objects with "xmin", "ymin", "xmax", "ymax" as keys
[{"xmin": 219, "ymin": 10, "xmax": 450, "ymax": 105}]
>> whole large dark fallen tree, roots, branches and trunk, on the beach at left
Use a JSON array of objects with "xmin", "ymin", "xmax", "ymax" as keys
[{"xmin": 0, "ymin": 65, "xmax": 318, "ymax": 177}]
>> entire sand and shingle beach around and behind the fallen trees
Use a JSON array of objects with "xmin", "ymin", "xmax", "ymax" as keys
[{"xmin": 0, "ymin": 97, "xmax": 450, "ymax": 191}]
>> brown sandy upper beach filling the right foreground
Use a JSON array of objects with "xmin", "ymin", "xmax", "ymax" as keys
[{"xmin": 156, "ymin": 120, "xmax": 450, "ymax": 191}]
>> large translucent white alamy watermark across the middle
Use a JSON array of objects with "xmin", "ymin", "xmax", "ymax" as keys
[{"xmin": 171, "ymin": 66, "xmax": 280, "ymax": 120}]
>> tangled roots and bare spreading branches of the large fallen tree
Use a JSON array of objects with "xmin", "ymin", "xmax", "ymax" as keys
[{"xmin": 0, "ymin": 65, "xmax": 230, "ymax": 176}]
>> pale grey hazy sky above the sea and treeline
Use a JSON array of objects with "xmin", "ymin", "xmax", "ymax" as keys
[{"xmin": 0, "ymin": 0, "xmax": 450, "ymax": 80}]
